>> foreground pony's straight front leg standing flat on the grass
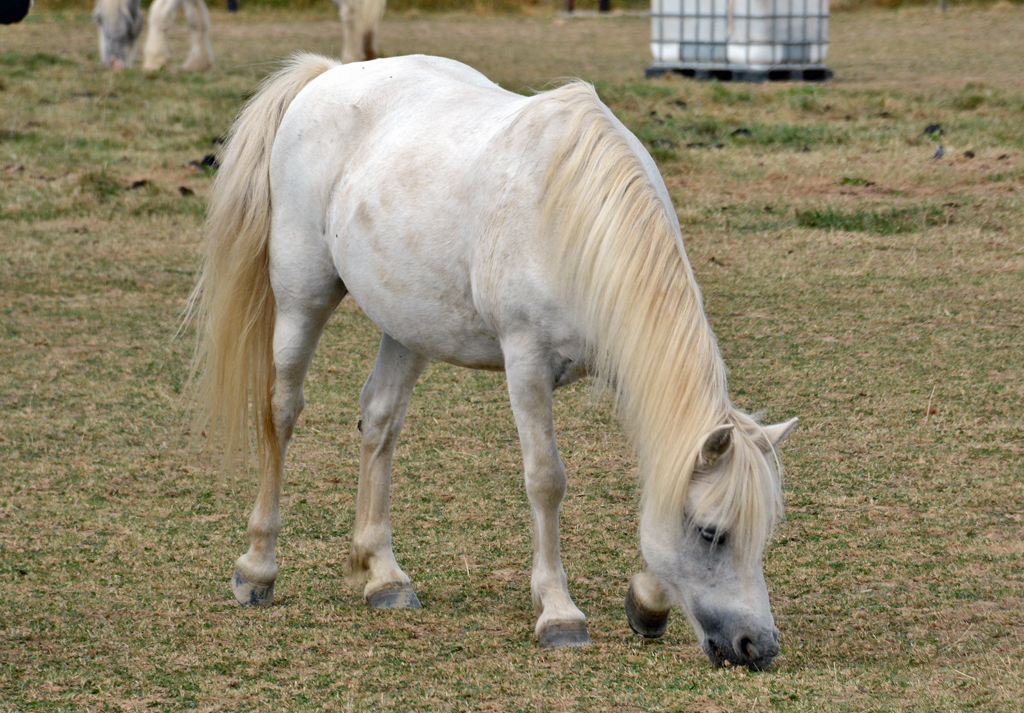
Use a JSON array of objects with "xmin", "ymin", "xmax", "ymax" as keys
[{"xmin": 502, "ymin": 343, "xmax": 590, "ymax": 648}]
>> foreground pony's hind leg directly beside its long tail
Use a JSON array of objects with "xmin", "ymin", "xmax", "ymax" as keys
[{"xmin": 231, "ymin": 267, "xmax": 345, "ymax": 606}]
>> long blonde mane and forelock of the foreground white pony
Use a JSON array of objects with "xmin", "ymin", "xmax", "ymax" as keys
[{"xmin": 537, "ymin": 82, "xmax": 781, "ymax": 550}]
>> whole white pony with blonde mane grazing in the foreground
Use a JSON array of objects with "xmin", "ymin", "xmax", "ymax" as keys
[{"xmin": 191, "ymin": 54, "xmax": 796, "ymax": 668}]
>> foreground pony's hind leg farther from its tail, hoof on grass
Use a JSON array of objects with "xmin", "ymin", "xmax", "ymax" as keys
[{"xmin": 349, "ymin": 334, "xmax": 429, "ymax": 609}]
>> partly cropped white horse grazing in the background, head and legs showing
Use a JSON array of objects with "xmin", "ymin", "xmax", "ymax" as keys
[{"xmin": 92, "ymin": 0, "xmax": 386, "ymax": 72}]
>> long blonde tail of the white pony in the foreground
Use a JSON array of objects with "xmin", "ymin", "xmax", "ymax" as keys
[{"xmin": 188, "ymin": 53, "xmax": 339, "ymax": 470}]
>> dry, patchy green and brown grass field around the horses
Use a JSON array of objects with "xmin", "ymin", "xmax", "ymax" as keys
[{"xmin": 0, "ymin": 3, "xmax": 1024, "ymax": 712}]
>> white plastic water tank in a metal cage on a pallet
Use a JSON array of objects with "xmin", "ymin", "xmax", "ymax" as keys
[{"xmin": 650, "ymin": 0, "xmax": 828, "ymax": 70}]
